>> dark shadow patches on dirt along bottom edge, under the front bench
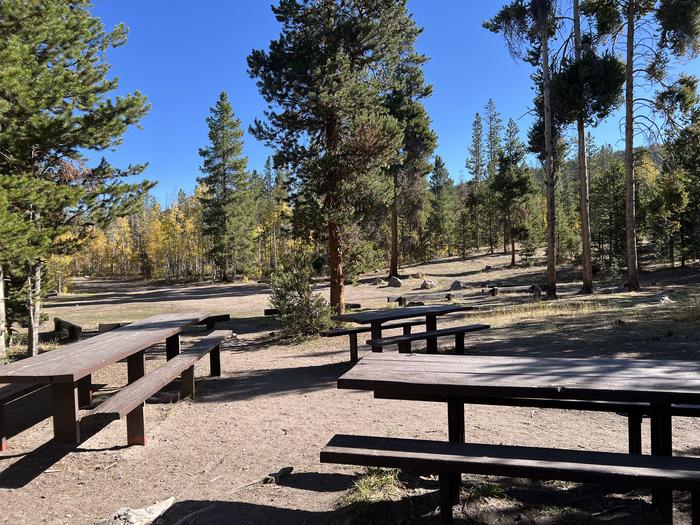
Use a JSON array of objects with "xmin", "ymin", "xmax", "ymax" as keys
[{"xmin": 158, "ymin": 472, "xmax": 672, "ymax": 525}]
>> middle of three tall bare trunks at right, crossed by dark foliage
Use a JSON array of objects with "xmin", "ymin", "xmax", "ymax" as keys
[{"xmin": 574, "ymin": 0, "xmax": 593, "ymax": 294}]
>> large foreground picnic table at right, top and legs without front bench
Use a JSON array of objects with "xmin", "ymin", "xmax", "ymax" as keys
[{"xmin": 338, "ymin": 353, "xmax": 700, "ymax": 516}]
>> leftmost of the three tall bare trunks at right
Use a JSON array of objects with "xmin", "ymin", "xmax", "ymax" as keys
[{"xmin": 538, "ymin": 2, "xmax": 557, "ymax": 299}]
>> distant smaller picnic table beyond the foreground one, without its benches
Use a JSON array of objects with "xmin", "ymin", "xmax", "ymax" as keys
[{"xmin": 333, "ymin": 304, "xmax": 474, "ymax": 354}]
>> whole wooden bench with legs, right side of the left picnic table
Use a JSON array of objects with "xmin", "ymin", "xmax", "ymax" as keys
[{"xmin": 90, "ymin": 330, "xmax": 231, "ymax": 445}]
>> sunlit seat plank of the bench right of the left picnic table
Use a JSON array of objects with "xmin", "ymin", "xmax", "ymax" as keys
[{"xmin": 90, "ymin": 330, "xmax": 231, "ymax": 420}]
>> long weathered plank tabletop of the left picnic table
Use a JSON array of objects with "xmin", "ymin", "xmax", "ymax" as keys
[{"xmin": 0, "ymin": 312, "xmax": 209, "ymax": 383}]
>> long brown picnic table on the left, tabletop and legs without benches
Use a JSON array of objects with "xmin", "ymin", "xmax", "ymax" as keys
[{"xmin": 0, "ymin": 312, "xmax": 209, "ymax": 443}]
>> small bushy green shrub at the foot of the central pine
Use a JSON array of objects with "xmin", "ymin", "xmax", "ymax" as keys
[{"xmin": 270, "ymin": 248, "xmax": 331, "ymax": 337}]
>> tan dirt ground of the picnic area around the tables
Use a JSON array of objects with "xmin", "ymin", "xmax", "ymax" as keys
[{"xmin": 0, "ymin": 252, "xmax": 700, "ymax": 525}]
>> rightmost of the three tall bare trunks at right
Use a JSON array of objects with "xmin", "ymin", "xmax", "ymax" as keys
[{"xmin": 625, "ymin": 0, "xmax": 639, "ymax": 292}]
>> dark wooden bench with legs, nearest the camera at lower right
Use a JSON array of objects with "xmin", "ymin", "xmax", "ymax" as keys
[{"xmin": 321, "ymin": 435, "xmax": 700, "ymax": 525}]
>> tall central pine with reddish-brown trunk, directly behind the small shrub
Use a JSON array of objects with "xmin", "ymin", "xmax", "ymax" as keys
[{"xmin": 248, "ymin": 0, "xmax": 420, "ymax": 312}]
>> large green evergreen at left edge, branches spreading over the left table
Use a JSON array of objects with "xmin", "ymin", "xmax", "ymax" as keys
[{"xmin": 0, "ymin": 0, "xmax": 151, "ymax": 355}]
